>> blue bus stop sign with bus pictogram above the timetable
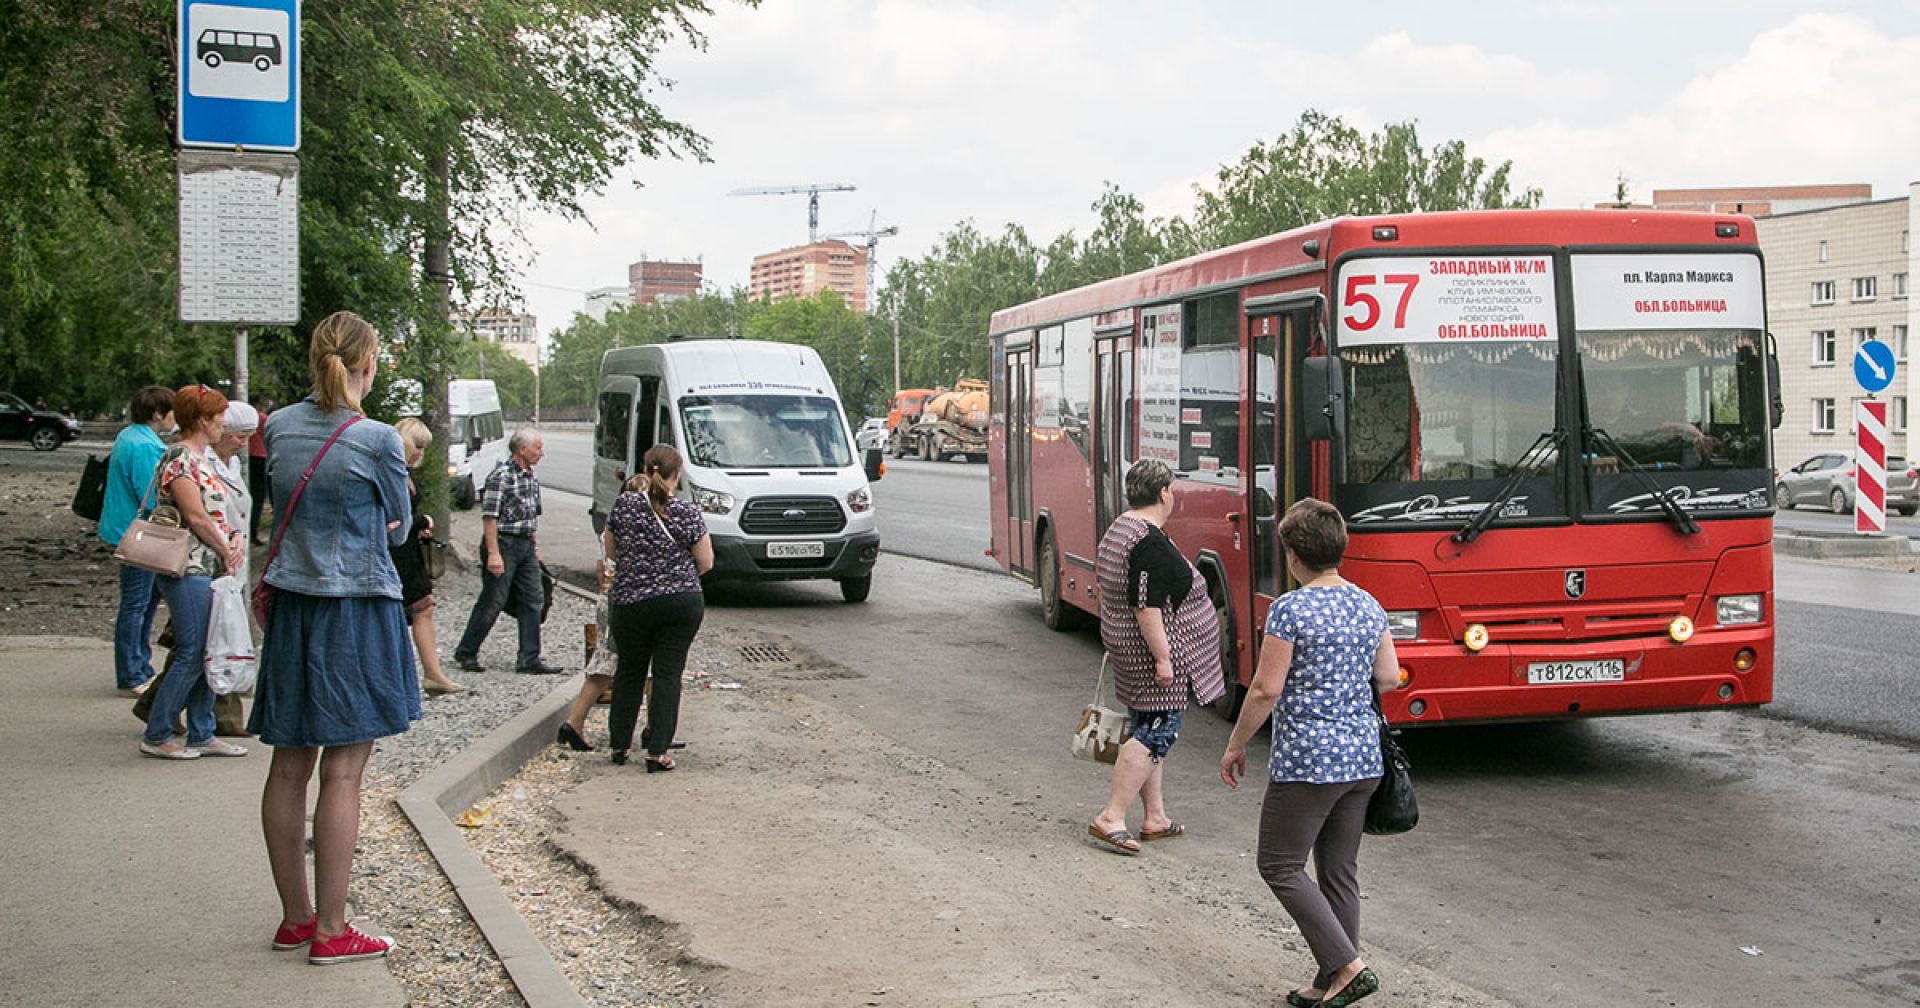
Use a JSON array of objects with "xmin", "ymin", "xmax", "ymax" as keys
[{"xmin": 179, "ymin": 0, "xmax": 300, "ymax": 154}]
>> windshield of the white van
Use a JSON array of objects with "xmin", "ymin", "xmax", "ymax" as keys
[{"xmin": 680, "ymin": 396, "xmax": 852, "ymax": 468}]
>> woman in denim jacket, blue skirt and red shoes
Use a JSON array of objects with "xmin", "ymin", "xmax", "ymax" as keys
[{"xmin": 248, "ymin": 311, "xmax": 420, "ymax": 964}]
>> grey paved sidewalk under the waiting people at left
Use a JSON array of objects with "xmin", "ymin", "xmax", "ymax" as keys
[{"xmin": 0, "ymin": 637, "xmax": 405, "ymax": 1008}]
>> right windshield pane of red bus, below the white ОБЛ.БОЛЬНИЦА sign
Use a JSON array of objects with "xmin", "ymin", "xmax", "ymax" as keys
[{"xmin": 1578, "ymin": 330, "xmax": 1770, "ymax": 515}]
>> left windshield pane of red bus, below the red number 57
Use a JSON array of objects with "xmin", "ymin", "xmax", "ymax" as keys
[{"xmin": 1336, "ymin": 340, "xmax": 1567, "ymax": 526}]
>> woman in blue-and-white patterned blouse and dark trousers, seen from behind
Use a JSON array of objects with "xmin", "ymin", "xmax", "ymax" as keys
[{"xmin": 1219, "ymin": 497, "xmax": 1400, "ymax": 1008}]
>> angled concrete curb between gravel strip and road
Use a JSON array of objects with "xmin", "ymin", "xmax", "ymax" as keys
[{"xmin": 399, "ymin": 676, "xmax": 586, "ymax": 1008}]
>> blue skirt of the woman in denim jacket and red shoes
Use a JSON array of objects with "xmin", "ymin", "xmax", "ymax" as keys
[{"xmin": 248, "ymin": 589, "xmax": 420, "ymax": 749}]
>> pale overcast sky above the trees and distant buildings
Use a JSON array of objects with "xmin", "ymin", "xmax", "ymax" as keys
[{"xmin": 522, "ymin": 0, "xmax": 1920, "ymax": 332}]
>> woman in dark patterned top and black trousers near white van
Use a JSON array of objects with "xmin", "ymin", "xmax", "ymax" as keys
[{"xmin": 595, "ymin": 445, "xmax": 714, "ymax": 774}]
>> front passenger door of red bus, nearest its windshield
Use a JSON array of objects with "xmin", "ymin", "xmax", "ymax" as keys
[{"xmin": 1246, "ymin": 294, "xmax": 1319, "ymax": 629}]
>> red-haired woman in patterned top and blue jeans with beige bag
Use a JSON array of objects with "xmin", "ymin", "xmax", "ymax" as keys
[{"xmin": 140, "ymin": 386, "xmax": 246, "ymax": 760}]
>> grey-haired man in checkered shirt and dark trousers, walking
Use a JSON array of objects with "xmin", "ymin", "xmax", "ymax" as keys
[{"xmin": 453, "ymin": 426, "xmax": 564, "ymax": 676}]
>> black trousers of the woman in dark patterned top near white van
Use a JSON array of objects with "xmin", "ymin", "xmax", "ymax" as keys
[{"xmin": 607, "ymin": 591, "xmax": 707, "ymax": 756}]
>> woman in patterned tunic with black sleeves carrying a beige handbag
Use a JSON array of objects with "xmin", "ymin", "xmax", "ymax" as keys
[{"xmin": 1087, "ymin": 461, "xmax": 1227, "ymax": 854}]
